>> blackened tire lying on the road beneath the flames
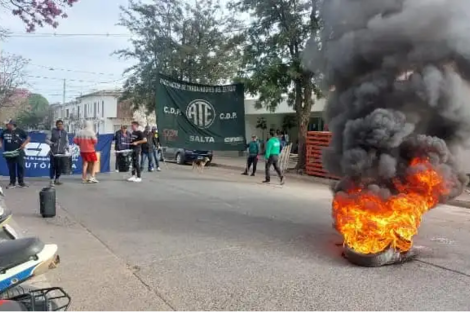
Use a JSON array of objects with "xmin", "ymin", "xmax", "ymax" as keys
[{"xmin": 343, "ymin": 245, "xmax": 417, "ymax": 267}]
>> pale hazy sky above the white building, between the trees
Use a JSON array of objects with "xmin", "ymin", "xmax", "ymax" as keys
[{"xmin": 0, "ymin": 0, "xmax": 135, "ymax": 103}]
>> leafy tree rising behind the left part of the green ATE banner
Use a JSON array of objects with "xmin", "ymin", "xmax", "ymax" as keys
[{"xmin": 116, "ymin": 0, "xmax": 241, "ymax": 113}]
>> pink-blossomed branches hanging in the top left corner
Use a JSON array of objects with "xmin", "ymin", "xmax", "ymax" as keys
[{"xmin": 0, "ymin": 0, "xmax": 78, "ymax": 32}]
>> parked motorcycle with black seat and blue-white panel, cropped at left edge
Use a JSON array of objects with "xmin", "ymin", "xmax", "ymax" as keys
[{"xmin": 0, "ymin": 188, "xmax": 71, "ymax": 311}]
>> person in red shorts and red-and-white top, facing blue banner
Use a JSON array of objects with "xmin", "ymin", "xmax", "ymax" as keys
[{"xmin": 73, "ymin": 121, "xmax": 98, "ymax": 184}]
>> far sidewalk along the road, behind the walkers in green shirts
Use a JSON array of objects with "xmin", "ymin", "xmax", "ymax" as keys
[{"xmin": 212, "ymin": 155, "xmax": 470, "ymax": 209}]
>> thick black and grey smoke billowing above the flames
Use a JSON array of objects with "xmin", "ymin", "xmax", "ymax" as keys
[{"xmin": 303, "ymin": 0, "xmax": 470, "ymax": 201}]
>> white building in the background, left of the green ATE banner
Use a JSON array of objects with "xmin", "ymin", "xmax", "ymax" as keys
[{"xmin": 52, "ymin": 90, "xmax": 155, "ymax": 134}]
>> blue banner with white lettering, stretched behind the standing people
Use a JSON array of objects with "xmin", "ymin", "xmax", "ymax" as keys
[{"xmin": 0, "ymin": 132, "xmax": 114, "ymax": 177}]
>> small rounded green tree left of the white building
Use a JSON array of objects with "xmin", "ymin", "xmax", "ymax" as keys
[{"xmin": 16, "ymin": 93, "xmax": 52, "ymax": 130}]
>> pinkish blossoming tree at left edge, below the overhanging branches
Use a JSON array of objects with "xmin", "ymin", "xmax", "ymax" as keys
[{"xmin": 0, "ymin": 52, "xmax": 28, "ymax": 108}]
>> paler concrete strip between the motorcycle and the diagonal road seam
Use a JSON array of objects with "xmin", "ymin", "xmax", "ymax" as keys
[{"xmin": 2, "ymin": 179, "xmax": 171, "ymax": 311}]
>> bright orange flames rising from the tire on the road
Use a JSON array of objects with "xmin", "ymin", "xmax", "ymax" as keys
[{"xmin": 333, "ymin": 158, "xmax": 448, "ymax": 254}]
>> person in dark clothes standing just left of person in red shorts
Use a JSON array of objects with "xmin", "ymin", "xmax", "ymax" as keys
[{"xmin": 46, "ymin": 120, "xmax": 69, "ymax": 186}]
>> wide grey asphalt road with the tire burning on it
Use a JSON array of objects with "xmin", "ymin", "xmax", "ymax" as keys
[{"xmin": 7, "ymin": 165, "xmax": 470, "ymax": 311}]
